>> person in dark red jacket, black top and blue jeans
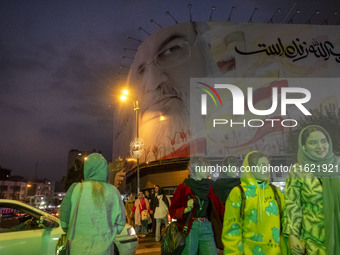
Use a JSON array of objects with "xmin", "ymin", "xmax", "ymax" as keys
[{"xmin": 169, "ymin": 158, "xmax": 224, "ymax": 255}]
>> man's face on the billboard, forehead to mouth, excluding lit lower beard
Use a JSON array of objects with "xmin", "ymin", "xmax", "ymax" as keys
[{"xmin": 131, "ymin": 23, "xmax": 205, "ymax": 119}]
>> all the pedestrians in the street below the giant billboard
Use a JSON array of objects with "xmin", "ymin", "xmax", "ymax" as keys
[{"xmin": 60, "ymin": 125, "xmax": 340, "ymax": 255}]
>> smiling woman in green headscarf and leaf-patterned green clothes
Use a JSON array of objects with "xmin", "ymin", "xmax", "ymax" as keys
[{"xmin": 284, "ymin": 125, "xmax": 340, "ymax": 255}]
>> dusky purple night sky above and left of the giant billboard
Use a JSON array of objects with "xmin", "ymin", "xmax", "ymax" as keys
[{"xmin": 0, "ymin": 0, "xmax": 340, "ymax": 180}]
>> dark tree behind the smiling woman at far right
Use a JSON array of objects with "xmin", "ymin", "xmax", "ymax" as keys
[{"xmin": 286, "ymin": 105, "xmax": 340, "ymax": 164}]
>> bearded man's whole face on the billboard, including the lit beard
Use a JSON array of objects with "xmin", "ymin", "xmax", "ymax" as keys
[{"xmin": 129, "ymin": 23, "xmax": 210, "ymax": 151}]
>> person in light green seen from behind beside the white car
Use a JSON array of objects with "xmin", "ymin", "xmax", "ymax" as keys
[{"xmin": 59, "ymin": 153, "xmax": 125, "ymax": 255}]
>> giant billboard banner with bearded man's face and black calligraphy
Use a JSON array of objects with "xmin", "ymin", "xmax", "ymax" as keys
[{"xmin": 113, "ymin": 22, "xmax": 340, "ymax": 162}]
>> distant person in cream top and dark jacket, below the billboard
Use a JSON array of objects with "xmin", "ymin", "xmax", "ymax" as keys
[{"xmin": 151, "ymin": 185, "xmax": 169, "ymax": 242}]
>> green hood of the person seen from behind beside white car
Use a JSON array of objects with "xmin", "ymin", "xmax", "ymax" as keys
[{"xmin": 84, "ymin": 153, "xmax": 109, "ymax": 182}]
